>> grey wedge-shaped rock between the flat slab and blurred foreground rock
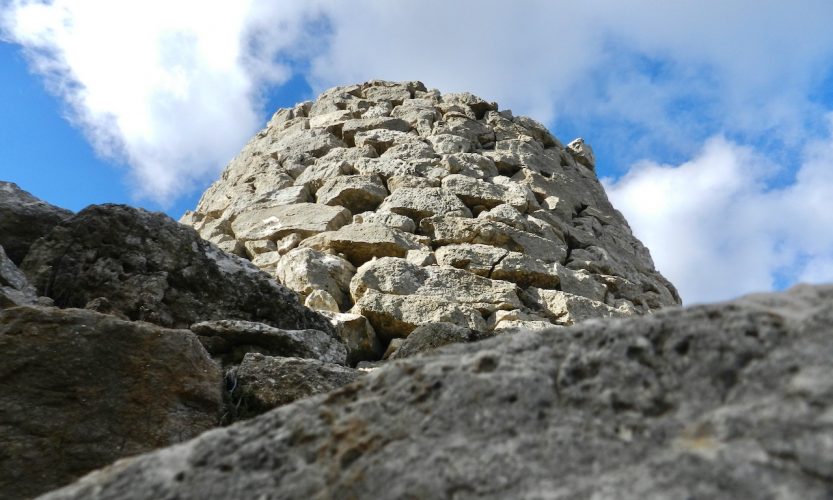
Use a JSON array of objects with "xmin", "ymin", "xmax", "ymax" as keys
[{"xmin": 231, "ymin": 353, "xmax": 362, "ymax": 419}]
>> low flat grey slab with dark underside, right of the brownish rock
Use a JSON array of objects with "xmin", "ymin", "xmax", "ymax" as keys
[{"xmin": 191, "ymin": 320, "xmax": 347, "ymax": 365}]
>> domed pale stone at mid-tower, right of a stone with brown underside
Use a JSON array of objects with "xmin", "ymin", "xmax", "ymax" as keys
[{"xmin": 379, "ymin": 188, "xmax": 471, "ymax": 223}]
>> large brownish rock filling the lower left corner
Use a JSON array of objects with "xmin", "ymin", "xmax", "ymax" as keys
[{"xmin": 0, "ymin": 307, "xmax": 222, "ymax": 498}]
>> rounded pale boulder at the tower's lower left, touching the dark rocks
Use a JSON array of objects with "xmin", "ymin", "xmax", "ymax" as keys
[{"xmin": 275, "ymin": 248, "xmax": 356, "ymax": 311}]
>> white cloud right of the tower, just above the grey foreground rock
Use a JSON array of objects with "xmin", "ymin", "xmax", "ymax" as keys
[{"xmin": 607, "ymin": 127, "xmax": 833, "ymax": 303}]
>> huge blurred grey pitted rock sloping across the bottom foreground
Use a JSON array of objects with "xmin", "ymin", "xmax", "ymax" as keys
[{"xmin": 46, "ymin": 286, "xmax": 833, "ymax": 499}]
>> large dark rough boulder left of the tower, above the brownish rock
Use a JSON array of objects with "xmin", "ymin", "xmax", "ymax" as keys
[{"xmin": 21, "ymin": 201, "xmax": 331, "ymax": 331}]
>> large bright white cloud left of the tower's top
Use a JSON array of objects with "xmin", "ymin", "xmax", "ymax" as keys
[{"xmin": 2, "ymin": 0, "xmax": 322, "ymax": 204}]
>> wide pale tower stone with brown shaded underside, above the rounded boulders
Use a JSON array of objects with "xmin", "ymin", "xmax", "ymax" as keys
[{"xmin": 301, "ymin": 223, "xmax": 425, "ymax": 266}]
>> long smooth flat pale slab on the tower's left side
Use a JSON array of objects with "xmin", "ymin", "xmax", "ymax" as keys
[{"xmin": 231, "ymin": 203, "xmax": 352, "ymax": 241}]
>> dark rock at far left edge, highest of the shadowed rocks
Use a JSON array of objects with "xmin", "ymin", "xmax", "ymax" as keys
[{"xmin": 0, "ymin": 181, "xmax": 72, "ymax": 265}]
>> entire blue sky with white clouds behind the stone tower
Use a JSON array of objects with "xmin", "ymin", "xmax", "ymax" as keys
[{"xmin": 0, "ymin": 0, "xmax": 833, "ymax": 303}]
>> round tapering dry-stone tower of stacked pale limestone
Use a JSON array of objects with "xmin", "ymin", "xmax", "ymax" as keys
[{"xmin": 182, "ymin": 81, "xmax": 680, "ymax": 352}]
